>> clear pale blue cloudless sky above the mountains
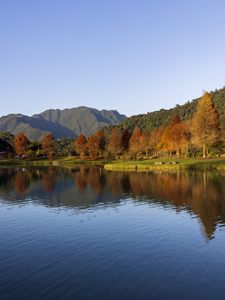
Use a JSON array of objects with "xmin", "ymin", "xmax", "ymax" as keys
[{"xmin": 0, "ymin": 0, "xmax": 225, "ymax": 116}]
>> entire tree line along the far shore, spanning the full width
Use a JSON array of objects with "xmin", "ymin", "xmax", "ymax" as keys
[{"xmin": 0, "ymin": 92, "xmax": 221, "ymax": 160}]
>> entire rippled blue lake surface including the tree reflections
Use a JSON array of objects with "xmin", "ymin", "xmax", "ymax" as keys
[{"xmin": 0, "ymin": 167, "xmax": 225, "ymax": 300}]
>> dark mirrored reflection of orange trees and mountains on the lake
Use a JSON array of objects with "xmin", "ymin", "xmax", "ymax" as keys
[{"xmin": 0, "ymin": 166, "xmax": 225, "ymax": 239}]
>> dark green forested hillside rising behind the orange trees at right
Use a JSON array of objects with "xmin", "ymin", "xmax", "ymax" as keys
[{"xmin": 110, "ymin": 87, "xmax": 225, "ymax": 132}]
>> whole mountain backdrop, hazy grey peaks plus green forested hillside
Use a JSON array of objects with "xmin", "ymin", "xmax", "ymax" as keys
[{"xmin": 0, "ymin": 87, "xmax": 225, "ymax": 139}]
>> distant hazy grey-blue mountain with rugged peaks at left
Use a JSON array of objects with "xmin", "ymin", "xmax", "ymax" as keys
[{"xmin": 0, "ymin": 106, "xmax": 126, "ymax": 140}]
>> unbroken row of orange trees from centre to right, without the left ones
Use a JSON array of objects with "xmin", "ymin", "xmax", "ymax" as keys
[{"xmin": 75, "ymin": 92, "xmax": 223, "ymax": 160}]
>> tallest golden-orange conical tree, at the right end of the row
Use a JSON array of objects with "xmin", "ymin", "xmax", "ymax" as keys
[{"xmin": 192, "ymin": 92, "xmax": 220, "ymax": 158}]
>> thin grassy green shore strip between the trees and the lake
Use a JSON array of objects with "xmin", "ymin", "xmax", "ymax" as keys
[{"xmin": 0, "ymin": 157, "xmax": 225, "ymax": 172}]
